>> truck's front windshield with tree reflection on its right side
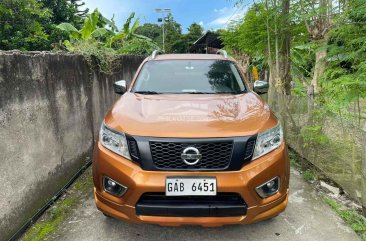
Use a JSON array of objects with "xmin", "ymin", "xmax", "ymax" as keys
[{"xmin": 133, "ymin": 60, "xmax": 245, "ymax": 94}]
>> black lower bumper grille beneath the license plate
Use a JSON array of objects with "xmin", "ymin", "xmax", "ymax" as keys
[{"xmin": 136, "ymin": 193, "xmax": 247, "ymax": 217}]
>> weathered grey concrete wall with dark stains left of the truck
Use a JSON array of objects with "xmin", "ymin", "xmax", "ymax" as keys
[{"xmin": 0, "ymin": 52, "xmax": 143, "ymax": 240}]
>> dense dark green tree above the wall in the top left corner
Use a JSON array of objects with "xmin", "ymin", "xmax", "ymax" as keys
[{"xmin": 0, "ymin": 0, "xmax": 52, "ymax": 50}]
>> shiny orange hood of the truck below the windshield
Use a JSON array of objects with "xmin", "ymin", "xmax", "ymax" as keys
[{"xmin": 105, "ymin": 92, "xmax": 277, "ymax": 138}]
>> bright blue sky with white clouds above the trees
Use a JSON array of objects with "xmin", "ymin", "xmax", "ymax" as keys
[{"xmin": 84, "ymin": 0, "xmax": 252, "ymax": 33}]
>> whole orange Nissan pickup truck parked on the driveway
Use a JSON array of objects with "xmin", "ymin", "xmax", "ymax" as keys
[{"xmin": 93, "ymin": 50, "xmax": 289, "ymax": 227}]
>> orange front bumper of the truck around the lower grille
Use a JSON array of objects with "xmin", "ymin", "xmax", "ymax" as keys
[{"xmin": 93, "ymin": 142, "xmax": 289, "ymax": 227}]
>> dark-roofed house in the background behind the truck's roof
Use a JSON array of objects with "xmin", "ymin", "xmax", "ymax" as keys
[{"xmin": 189, "ymin": 31, "xmax": 224, "ymax": 54}]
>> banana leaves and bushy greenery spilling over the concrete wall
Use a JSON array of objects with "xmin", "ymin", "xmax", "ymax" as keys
[{"xmin": 57, "ymin": 9, "xmax": 158, "ymax": 73}]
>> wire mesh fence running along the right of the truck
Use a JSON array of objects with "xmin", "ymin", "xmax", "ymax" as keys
[{"xmin": 264, "ymin": 90, "xmax": 366, "ymax": 207}]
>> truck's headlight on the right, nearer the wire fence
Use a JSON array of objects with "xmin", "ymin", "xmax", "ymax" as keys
[{"xmin": 253, "ymin": 122, "xmax": 283, "ymax": 160}]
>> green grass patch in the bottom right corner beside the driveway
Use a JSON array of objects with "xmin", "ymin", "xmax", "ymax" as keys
[{"xmin": 323, "ymin": 196, "xmax": 366, "ymax": 241}]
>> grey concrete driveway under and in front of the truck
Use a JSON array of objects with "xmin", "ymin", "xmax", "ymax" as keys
[{"xmin": 42, "ymin": 170, "xmax": 360, "ymax": 241}]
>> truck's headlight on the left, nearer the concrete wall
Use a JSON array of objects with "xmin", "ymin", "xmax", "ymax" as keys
[{"xmin": 99, "ymin": 123, "xmax": 131, "ymax": 160}]
